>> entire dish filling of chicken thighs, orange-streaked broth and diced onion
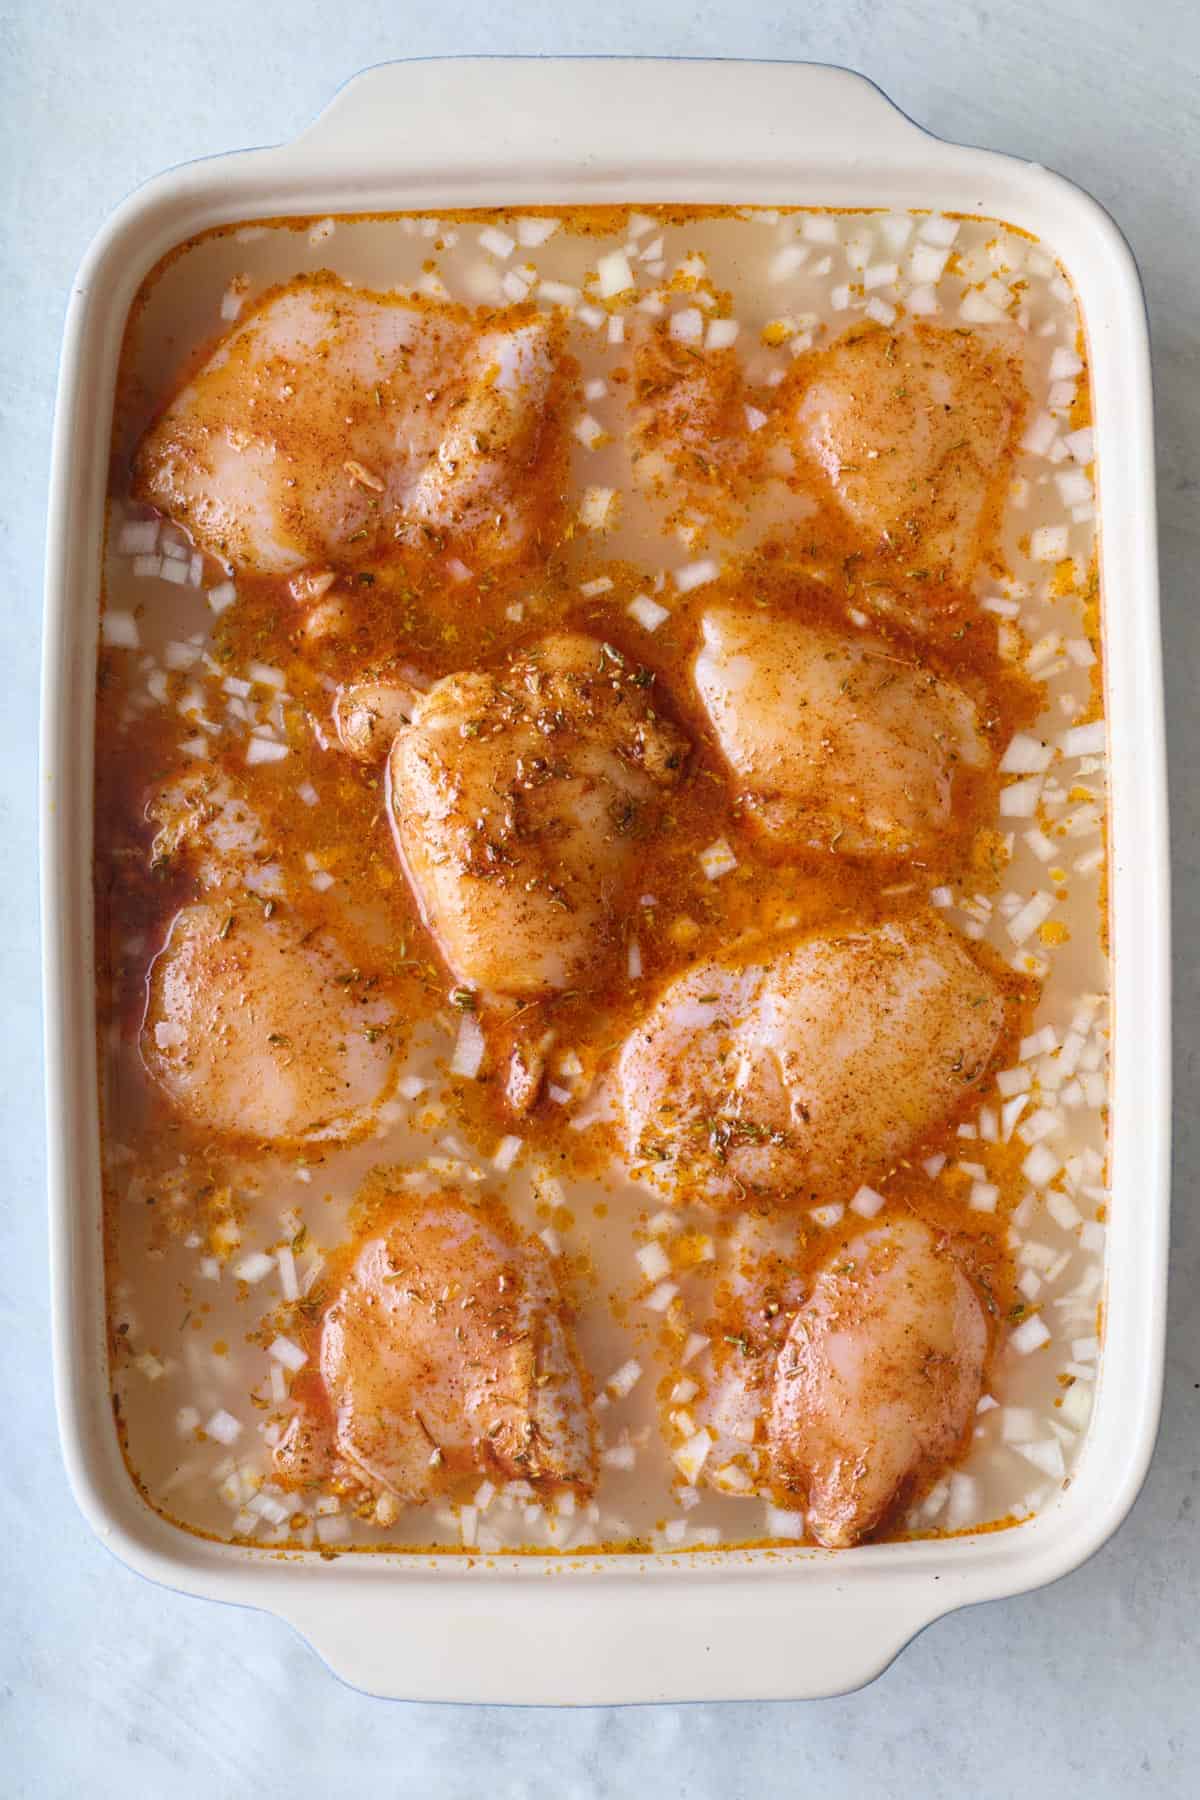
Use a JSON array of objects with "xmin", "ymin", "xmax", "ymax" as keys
[{"xmin": 95, "ymin": 207, "xmax": 1108, "ymax": 1553}]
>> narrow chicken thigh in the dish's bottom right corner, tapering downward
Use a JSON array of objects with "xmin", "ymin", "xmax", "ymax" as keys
[{"xmin": 768, "ymin": 1219, "xmax": 988, "ymax": 1550}]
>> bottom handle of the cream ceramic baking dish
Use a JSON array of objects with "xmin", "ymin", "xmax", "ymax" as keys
[{"xmin": 279, "ymin": 1559, "xmax": 966, "ymax": 1706}]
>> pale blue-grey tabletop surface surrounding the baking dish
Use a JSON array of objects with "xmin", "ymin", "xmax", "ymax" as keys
[{"xmin": 0, "ymin": 0, "xmax": 1200, "ymax": 1800}]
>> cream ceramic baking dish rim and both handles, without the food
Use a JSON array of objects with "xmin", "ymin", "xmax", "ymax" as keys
[{"xmin": 43, "ymin": 61, "xmax": 1169, "ymax": 1703}]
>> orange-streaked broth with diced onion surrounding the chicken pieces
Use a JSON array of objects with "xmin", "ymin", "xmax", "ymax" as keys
[{"xmin": 95, "ymin": 209, "xmax": 1108, "ymax": 1550}]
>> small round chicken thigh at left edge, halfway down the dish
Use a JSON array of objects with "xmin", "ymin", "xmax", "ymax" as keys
[{"xmin": 142, "ymin": 900, "xmax": 396, "ymax": 1145}]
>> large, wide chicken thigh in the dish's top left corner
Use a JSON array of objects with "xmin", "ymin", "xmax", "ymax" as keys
[{"xmin": 133, "ymin": 275, "xmax": 558, "ymax": 574}]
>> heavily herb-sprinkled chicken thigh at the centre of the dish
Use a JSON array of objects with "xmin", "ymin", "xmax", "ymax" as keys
[{"xmin": 389, "ymin": 634, "xmax": 687, "ymax": 997}]
